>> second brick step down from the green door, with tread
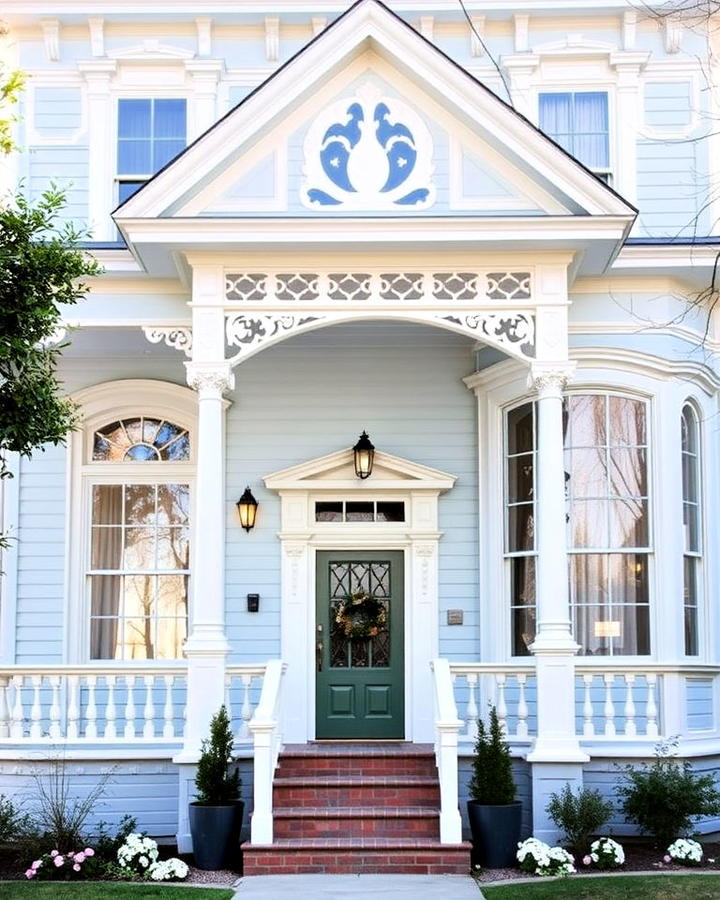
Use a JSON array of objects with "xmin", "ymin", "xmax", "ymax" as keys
[{"xmin": 273, "ymin": 775, "xmax": 440, "ymax": 811}]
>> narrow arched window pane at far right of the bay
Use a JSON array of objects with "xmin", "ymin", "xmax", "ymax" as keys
[{"xmin": 680, "ymin": 403, "xmax": 701, "ymax": 656}]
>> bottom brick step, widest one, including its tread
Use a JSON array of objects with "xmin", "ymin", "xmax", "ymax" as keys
[{"xmin": 243, "ymin": 838, "xmax": 470, "ymax": 875}]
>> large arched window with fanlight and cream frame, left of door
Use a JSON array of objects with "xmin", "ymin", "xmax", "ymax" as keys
[{"xmin": 76, "ymin": 381, "xmax": 195, "ymax": 660}]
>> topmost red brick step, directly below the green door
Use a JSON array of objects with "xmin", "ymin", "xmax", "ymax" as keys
[{"xmin": 276, "ymin": 742, "xmax": 437, "ymax": 778}]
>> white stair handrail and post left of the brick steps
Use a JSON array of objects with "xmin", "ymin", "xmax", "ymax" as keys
[{"xmin": 248, "ymin": 659, "xmax": 285, "ymax": 844}]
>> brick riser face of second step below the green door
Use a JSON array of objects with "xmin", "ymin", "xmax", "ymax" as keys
[{"xmin": 273, "ymin": 781, "xmax": 440, "ymax": 809}]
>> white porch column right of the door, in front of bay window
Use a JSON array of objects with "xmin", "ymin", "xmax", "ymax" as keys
[{"xmin": 528, "ymin": 365, "xmax": 587, "ymax": 763}]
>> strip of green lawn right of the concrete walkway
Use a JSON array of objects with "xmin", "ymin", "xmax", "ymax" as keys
[{"xmin": 481, "ymin": 875, "xmax": 720, "ymax": 900}]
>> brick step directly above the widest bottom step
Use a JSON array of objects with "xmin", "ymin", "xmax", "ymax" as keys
[{"xmin": 274, "ymin": 806, "xmax": 440, "ymax": 840}]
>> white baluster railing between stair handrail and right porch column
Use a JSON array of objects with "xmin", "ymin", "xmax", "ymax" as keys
[{"xmin": 449, "ymin": 663, "xmax": 535, "ymax": 743}]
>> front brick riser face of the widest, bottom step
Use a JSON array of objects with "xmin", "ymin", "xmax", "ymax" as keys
[{"xmin": 243, "ymin": 847, "xmax": 469, "ymax": 875}]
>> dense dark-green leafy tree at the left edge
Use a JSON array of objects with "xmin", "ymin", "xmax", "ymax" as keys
[{"xmin": 0, "ymin": 187, "xmax": 100, "ymax": 546}]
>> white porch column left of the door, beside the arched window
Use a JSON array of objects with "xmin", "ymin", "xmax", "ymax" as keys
[{"xmin": 175, "ymin": 363, "xmax": 233, "ymax": 762}]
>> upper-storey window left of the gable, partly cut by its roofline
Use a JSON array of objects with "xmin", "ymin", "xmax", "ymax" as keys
[{"xmin": 117, "ymin": 97, "xmax": 187, "ymax": 203}]
